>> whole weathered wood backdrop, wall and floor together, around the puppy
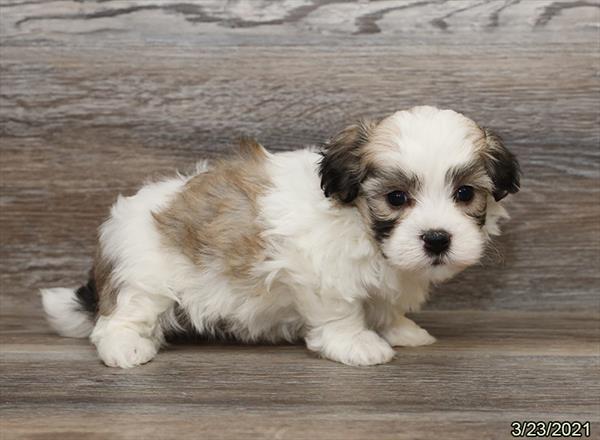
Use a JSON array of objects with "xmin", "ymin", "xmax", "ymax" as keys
[{"xmin": 0, "ymin": 0, "xmax": 600, "ymax": 440}]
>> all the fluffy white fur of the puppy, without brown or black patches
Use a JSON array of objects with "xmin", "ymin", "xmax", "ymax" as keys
[{"xmin": 42, "ymin": 107, "xmax": 516, "ymax": 368}]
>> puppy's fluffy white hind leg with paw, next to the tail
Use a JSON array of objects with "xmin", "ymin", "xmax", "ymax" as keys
[{"xmin": 90, "ymin": 286, "xmax": 174, "ymax": 368}]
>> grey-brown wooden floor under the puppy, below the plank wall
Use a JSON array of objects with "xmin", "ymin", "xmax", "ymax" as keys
[{"xmin": 0, "ymin": 311, "xmax": 600, "ymax": 439}]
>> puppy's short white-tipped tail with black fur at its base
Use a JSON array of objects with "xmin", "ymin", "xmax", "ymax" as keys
[{"xmin": 40, "ymin": 279, "xmax": 98, "ymax": 338}]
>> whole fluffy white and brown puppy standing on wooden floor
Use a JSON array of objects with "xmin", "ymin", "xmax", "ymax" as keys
[{"xmin": 42, "ymin": 107, "xmax": 519, "ymax": 368}]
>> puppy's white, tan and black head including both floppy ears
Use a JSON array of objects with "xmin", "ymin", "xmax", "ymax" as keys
[{"xmin": 320, "ymin": 106, "xmax": 520, "ymax": 281}]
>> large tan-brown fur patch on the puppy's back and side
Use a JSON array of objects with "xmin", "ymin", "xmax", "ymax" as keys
[{"xmin": 153, "ymin": 139, "xmax": 270, "ymax": 286}]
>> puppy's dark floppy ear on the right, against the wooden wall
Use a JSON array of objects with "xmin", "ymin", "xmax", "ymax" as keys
[{"xmin": 482, "ymin": 128, "xmax": 521, "ymax": 201}]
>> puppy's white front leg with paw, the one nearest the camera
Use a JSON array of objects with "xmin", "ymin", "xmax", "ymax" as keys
[{"xmin": 303, "ymin": 299, "xmax": 395, "ymax": 366}]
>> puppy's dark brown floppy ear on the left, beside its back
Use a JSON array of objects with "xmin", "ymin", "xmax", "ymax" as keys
[{"xmin": 319, "ymin": 121, "xmax": 376, "ymax": 203}]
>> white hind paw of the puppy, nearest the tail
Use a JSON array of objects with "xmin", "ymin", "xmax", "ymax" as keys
[{"xmin": 97, "ymin": 330, "xmax": 158, "ymax": 368}]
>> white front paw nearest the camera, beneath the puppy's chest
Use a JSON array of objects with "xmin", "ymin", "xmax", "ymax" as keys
[{"xmin": 321, "ymin": 330, "xmax": 396, "ymax": 366}]
